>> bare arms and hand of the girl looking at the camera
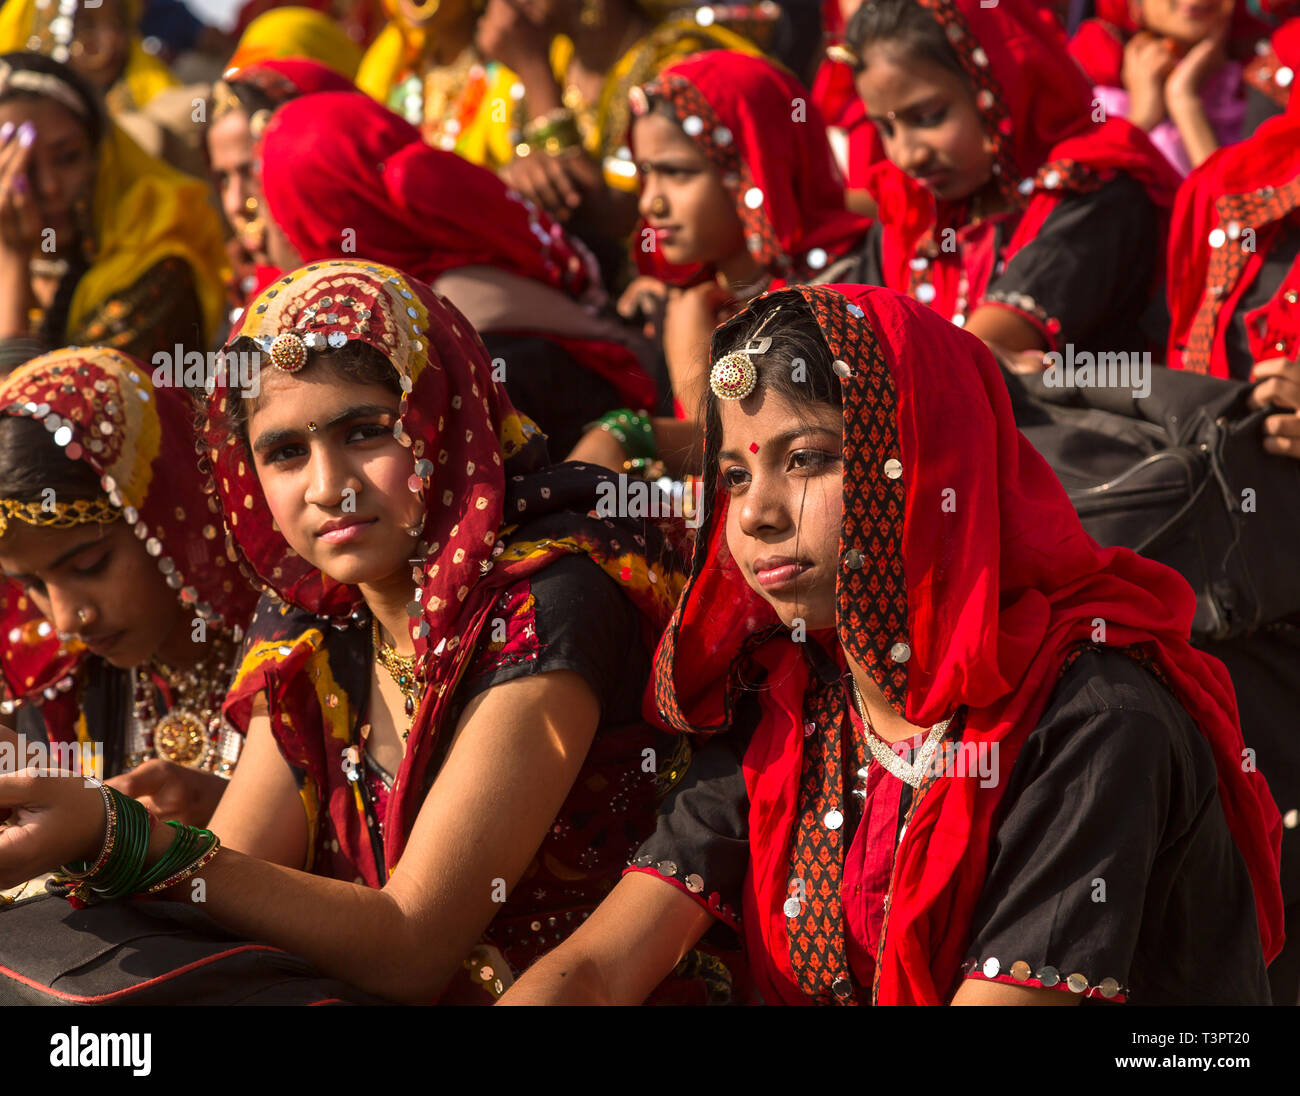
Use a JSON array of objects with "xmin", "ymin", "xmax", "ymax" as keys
[{"xmin": 0, "ymin": 671, "xmax": 599, "ymax": 1004}]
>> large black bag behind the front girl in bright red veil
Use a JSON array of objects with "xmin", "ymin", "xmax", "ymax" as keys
[{"xmin": 1004, "ymin": 360, "xmax": 1300, "ymax": 640}]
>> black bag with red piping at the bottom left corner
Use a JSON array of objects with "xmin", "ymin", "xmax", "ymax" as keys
[{"xmin": 0, "ymin": 896, "xmax": 387, "ymax": 1005}]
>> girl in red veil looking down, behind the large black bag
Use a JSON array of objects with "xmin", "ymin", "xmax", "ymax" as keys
[{"xmin": 840, "ymin": 0, "xmax": 1178, "ymax": 369}]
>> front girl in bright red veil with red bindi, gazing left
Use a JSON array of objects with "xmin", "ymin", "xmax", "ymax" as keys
[{"xmin": 507, "ymin": 286, "xmax": 1281, "ymax": 1004}]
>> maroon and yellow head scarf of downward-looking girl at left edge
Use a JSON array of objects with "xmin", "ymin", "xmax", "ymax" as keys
[{"xmin": 0, "ymin": 347, "xmax": 257, "ymax": 738}]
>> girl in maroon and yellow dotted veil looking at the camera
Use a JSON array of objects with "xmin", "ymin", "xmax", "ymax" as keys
[{"xmin": 0, "ymin": 260, "xmax": 731, "ymax": 1004}]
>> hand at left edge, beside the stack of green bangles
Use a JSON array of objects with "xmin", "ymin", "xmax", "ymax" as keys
[{"xmin": 0, "ymin": 768, "xmax": 107, "ymax": 889}]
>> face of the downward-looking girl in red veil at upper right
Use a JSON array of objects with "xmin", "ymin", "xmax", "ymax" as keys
[{"xmin": 855, "ymin": 44, "xmax": 993, "ymax": 202}]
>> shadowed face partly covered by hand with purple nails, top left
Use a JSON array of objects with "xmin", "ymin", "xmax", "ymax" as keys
[{"xmin": 0, "ymin": 98, "xmax": 99, "ymax": 247}]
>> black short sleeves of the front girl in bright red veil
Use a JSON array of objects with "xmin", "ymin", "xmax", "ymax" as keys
[{"xmin": 636, "ymin": 650, "xmax": 1269, "ymax": 1004}]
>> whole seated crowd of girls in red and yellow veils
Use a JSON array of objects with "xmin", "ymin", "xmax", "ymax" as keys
[{"xmin": 0, "ymin": 0, "xmax": 1300, "ymax": 1005}]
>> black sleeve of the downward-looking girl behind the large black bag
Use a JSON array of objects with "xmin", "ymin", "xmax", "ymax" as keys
[{"xmin": 984, "ymin": 176, "xmax": 1160, "ymax": 351}]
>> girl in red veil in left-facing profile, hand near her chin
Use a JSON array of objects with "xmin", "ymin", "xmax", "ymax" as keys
[{"xmin": 573, "ymin": 49, "xmax": 871, "ymax": 475}]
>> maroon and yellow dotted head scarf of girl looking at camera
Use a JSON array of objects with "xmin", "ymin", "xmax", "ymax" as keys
[{"xmin": 205, "ymin": 260, "xmax": 681, "ymax": 887}]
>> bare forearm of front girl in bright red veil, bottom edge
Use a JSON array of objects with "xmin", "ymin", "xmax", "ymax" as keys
[{"xmin": 498, "ymin": 871, "xmax": 712, "ymax": 1005}]
